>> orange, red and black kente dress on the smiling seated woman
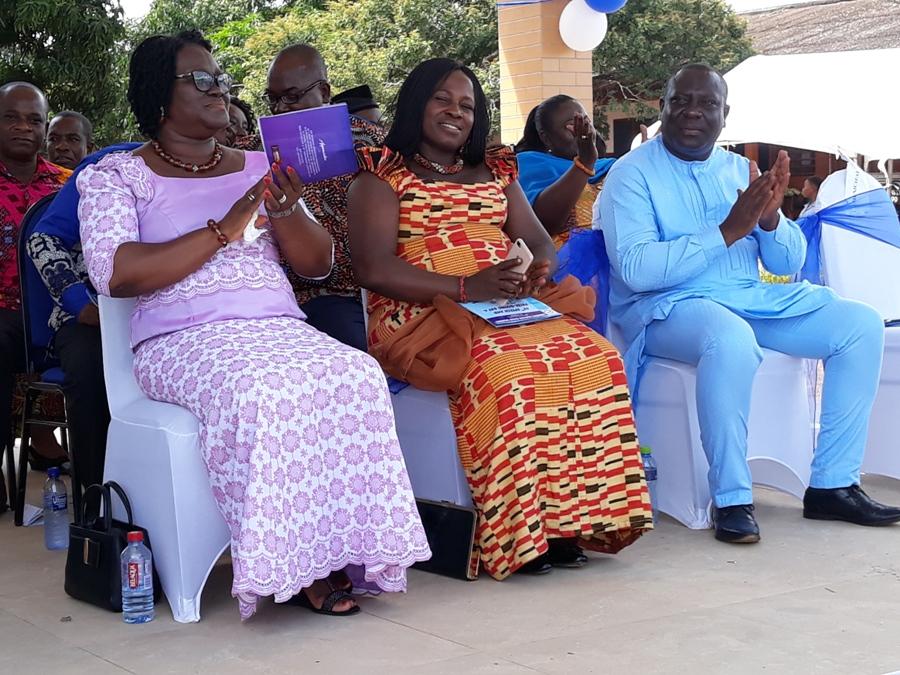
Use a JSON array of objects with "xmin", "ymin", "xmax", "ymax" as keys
[{"xmin": 359, "ymin": 148, "xmax": 652, "ymax": 579}]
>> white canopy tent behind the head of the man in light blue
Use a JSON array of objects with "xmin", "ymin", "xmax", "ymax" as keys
[{"xmin": 632, "ymin": 49, "xmax": 900, "ymax": 160}]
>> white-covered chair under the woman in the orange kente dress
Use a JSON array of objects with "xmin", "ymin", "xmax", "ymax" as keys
[{"xmin": 361, "ymin": 289, "xmax": 472, "ymax": 508}]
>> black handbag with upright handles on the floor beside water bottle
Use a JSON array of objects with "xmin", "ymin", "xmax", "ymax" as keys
[{"xmin": 65, "ymin": 481, "xmax": 161, "ymax": 612}]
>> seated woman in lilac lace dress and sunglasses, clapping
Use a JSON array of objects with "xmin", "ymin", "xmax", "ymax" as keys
[{"xmin": 78, "ymin": 33, "xmax": 430, "ymax": 618}]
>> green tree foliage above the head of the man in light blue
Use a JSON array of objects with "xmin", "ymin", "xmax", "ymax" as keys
[{"xmin": 594, "ymin": 0, "xmax": 753, "ymax": 116}]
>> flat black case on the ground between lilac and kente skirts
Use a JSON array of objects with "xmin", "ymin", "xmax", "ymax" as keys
[{"xmin": 413, "ymin": 499, "xmax": 478, "ymax": 581}]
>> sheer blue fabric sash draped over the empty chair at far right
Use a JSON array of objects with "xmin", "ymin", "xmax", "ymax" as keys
[{"xmin": 797, "ymin": 190, "xmax": 900, "ymax": 284}]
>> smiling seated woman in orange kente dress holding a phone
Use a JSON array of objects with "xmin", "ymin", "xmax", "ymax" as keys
[{"xmin": 349, "ymin": 59, "xmax": 652, "ymax": 579}]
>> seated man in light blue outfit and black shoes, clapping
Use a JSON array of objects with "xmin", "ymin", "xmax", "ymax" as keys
[{"xmin": 599, "ymin": 64, "xmax": 900, "ymax": 543}]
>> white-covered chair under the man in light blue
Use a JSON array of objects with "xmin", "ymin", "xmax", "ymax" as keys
[{"xmin": 608, "ymin": 324, "xmax": 813, "ymax": 529}]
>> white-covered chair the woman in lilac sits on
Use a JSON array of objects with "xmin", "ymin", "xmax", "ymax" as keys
[{"xmin": 100, "ymin": 297, "xmax": 231, "ymax": 623}]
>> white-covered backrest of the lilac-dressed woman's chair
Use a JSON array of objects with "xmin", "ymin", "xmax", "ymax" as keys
[{"xmin": 100, "ymin": 296, "xmax": 144, "ymax": 417}]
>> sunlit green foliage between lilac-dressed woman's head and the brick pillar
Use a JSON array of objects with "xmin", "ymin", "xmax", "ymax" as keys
[{"xmin": 211, "ymin": 0, "xmax": 499, "ymax": 129}]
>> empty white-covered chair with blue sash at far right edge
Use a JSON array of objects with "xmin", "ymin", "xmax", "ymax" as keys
[{"xmin": 821, "ymin": 222, "xmax": 900, "ymax": 478}]
